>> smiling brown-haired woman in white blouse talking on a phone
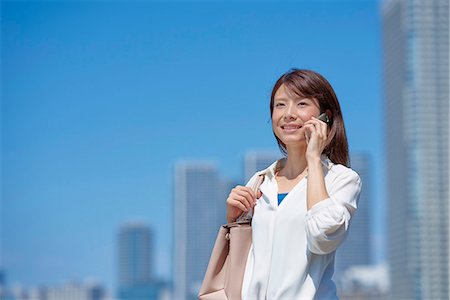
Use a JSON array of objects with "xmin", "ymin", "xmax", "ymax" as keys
[{"xmin": 227, "ymin": 69, "xmax": 362, "ymax": 299}]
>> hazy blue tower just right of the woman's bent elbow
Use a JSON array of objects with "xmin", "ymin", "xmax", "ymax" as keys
[{"xmin": 335, "ymin": 154, "xmax": 373, "ymax": 278}]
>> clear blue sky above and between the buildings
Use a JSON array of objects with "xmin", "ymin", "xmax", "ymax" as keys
[{"xmin": 1, "ymin": 1, "xmax": 385, "ymax": 294}]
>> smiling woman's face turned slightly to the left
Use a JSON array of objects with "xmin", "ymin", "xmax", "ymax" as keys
[{"xmin": 272, "ymin": 84, "xmax": 320, "ymax": 147}]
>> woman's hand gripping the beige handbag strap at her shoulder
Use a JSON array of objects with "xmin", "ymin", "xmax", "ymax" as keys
[{"xmin": 227, "ymin": 185, "xmax": 262, "ymax": 223}]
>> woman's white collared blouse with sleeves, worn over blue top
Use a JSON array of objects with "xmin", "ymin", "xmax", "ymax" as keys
[{"xmin": 242, "ymin": 154, "xmax": 362, "ymax": 300}]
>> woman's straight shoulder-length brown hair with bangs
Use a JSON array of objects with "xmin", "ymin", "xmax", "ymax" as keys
[{"xmin": 270, "ymin": 68, "xmax": 350, "ymax": 167}]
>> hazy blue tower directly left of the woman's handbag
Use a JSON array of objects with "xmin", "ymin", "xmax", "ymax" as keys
[{"xmin": 173, "ymin": 162, "xmax": 221, "ymax": 300}]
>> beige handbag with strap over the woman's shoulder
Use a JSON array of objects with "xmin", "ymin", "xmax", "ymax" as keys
[{"xmin": 198, "ymin": 174, "xmax": 264, "ymax": 300}]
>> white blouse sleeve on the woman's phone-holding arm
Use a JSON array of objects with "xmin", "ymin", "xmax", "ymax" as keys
[{"xmin": 305, "ymin": 170, "xmax": 362, "ymax": 254}]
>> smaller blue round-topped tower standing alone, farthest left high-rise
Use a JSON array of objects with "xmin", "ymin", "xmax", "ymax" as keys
[{"xmin": 118, "ymin": 222, "xmax": 159, "ymax": 300}]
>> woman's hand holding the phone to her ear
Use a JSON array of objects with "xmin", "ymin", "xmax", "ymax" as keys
[{"xmin": 304, "ymin": 117, "xmax": 328, "ymax": 161}]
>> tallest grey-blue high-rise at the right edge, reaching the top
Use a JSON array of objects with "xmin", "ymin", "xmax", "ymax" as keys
[{"xmin": 382, "ymin": 0, "xmax": 450, "ymax": 299}]
